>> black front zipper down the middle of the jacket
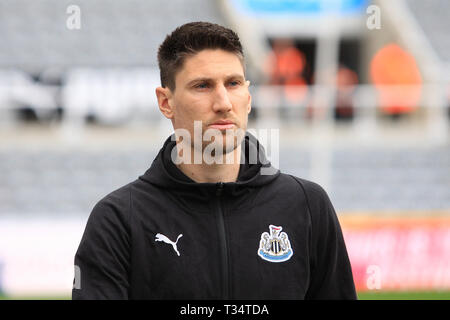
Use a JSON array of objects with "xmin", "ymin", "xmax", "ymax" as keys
[{"xmin": 216, "ymin": 182, "xmax": 230, "ymax": 300}]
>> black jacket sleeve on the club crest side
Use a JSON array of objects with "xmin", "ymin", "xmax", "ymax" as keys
[{"xmin": 302, "ymin": 181, "xmax": 357, "ymax": 300}]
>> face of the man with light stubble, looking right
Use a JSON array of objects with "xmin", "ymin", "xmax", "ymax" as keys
[{"xmin": 163, "ymin": 49, "xmax": 251, "ymax": 156}]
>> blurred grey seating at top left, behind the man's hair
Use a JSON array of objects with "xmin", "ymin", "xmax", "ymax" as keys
[{"xmin": 0, "ymin": 0, "xmax": 224, "ymax": 73}]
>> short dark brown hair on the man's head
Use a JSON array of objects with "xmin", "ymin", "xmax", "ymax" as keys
[{"xmin": 158, "ymin": 22, "xmax": 245, "ymax": 90}]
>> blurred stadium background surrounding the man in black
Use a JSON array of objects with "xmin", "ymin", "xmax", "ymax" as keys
[{"xmin": 0, "ymin": 0, "xmax": 450, "ymax": 299}]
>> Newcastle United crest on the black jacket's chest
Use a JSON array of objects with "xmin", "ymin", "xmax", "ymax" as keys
[{"xmin": 258, "ymin": 225, "xmax": 294, "ymax": 262}]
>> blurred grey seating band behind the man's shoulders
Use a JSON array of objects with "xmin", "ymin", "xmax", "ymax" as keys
[{"xmin": 0, "ymin": 148, "xmax": 450, "ymax": 216}]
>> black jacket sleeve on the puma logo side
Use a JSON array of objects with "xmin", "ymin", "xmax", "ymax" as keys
[{"xmin": 72, "ymin": 188, "xmax": 130, "ymax": 300}]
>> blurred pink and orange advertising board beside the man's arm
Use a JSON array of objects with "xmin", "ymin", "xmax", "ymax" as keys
[{"xmin": 339, "ymin": 213, "xmax": 450, "ymax": 291}]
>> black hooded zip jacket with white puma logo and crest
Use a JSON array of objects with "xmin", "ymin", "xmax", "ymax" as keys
[{"xmin": 72, "ymin": 135, "xmax": 356, "ymax": 299}]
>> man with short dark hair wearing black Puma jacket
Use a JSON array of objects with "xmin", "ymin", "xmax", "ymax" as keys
[{"xmin": 72, "ymin": 22, "xmax": 356, "ymax": 299}]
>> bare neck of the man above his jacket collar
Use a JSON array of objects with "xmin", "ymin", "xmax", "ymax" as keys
[{"xmin": 177, "ymin": 147, "xmax": 241, "ymax": 183}]
